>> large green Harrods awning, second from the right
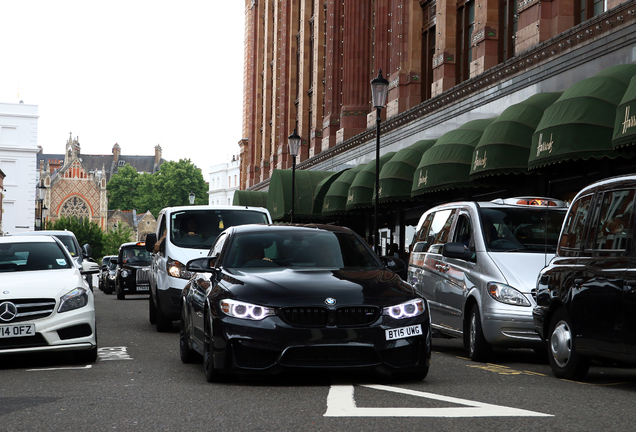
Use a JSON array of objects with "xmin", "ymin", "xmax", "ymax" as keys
[{"xmin": 528, "ymin": 64, "xmax": 636, "ymax": 169}]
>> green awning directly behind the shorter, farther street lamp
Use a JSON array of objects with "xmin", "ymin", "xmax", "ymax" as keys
[{"xmin": 267, "ymin": 169, "xmax": 334, "ymax": 220}]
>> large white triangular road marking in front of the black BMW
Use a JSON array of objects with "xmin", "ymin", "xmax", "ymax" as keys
[{"xmin": 324, "ymin": 385, "xmax": 553, "ymax": 417}]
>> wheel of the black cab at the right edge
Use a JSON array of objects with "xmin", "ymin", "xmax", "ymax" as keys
[{"xmin": 548, "ymin": 308, "xmax": 590, "ymax": 380}]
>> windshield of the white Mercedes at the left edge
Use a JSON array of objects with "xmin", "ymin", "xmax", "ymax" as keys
[{"xmin": 0, "ymin": 243, "xmax": 71, "ymax": 272}]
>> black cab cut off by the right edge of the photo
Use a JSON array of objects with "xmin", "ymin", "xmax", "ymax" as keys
[{"xmin": 533, "ymin": 175, "xmax": 636, "ymax": 379}]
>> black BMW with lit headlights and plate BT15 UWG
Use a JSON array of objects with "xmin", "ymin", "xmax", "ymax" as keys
[{"xmin": 180, "ymin": 225, "xmax": 431, "ymax": 381}]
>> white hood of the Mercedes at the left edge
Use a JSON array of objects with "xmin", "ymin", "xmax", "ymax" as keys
[{"xmin": 0, "ymin": 268, "xmax": 88, "ymax": 301}]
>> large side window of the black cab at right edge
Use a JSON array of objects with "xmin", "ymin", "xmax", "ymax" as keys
[{"xmin": 586, "ymin": 190, "xmax": 634, "ymax": 250}]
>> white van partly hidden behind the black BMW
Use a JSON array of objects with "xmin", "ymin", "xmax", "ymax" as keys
[{"xmin": 146, "ymin": 205, "xmax": 272, "ymax": 331}]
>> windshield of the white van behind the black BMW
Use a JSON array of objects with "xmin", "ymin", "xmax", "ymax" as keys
[{"xmin": 170, "ymin": 209, "xmax": 269, "ymax": 249}]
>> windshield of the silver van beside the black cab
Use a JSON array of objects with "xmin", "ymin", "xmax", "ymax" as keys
[{"xmin": 480, "ymin": 207, "xmax": 567, "ymax": 252}]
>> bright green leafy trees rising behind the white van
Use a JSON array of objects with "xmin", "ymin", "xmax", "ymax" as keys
[{"xmin": 107, "ymin": 159, "xmax": 208, "ymax": 217}]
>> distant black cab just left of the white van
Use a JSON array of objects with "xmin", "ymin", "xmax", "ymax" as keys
[{"xmin": 115, "ymin": 242, "xmax": 151, "ymax": 300}]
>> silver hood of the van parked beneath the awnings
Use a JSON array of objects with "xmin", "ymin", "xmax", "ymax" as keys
[{"xmin": 488, "ymin": 252, "xmax": 554, "ymax": 294}]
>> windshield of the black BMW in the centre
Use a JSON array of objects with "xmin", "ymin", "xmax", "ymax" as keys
[{"xmin": 224, "ymin": 229, "xmax": 380, "ymax": 269}]
